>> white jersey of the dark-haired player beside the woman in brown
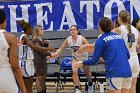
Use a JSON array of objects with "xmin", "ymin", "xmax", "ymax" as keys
[{"xmin": 19, "ymin": 34, "xmax": 34, "ymax": 60}]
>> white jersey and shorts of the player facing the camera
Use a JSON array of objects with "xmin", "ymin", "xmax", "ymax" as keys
[{"xmin": 68, "ymin": 35, "xmax": 88, "ymax": 61}]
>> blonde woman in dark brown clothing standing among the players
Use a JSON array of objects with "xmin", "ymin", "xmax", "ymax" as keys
[{"xmin": 32, "ymin": 25, "xmax": 53, "ymax": 93}]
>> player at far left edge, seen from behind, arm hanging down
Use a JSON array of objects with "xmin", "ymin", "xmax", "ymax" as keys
[{"xmin": 0, "ymin": 9, "xmax": 26, "ymax": 93}]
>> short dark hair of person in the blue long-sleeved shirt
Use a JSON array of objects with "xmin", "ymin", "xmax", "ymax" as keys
[{"xmin": 99, "ymin": 17, "xmax": 112, "ymax": 33}]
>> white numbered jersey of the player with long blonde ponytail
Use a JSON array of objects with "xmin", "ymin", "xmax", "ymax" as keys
[{"xmin": 121, "ymin": 25, "xmax": 138, "ymax": 55}]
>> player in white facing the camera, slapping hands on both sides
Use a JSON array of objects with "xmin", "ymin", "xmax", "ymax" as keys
[{"xmin": 54, "ymin": 25, "xmax": 93, "ymax": 93}]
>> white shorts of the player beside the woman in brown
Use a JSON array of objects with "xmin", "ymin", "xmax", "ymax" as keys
[{"xmin": 19, "ymin": 60, "xmax": 35, "ymax": 77}]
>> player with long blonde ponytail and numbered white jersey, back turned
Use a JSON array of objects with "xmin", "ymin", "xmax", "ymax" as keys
[{"xmin": 116, "ymin": 10, "xmax": 140, "ymax": 93}]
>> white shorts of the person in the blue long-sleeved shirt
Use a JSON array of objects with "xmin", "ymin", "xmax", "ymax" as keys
[{"xmin": 106, "ymin": 77, "xmax": 132, "ymax": 90}]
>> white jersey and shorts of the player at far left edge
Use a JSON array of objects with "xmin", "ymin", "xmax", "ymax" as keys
[{"xmin": 0, "ymin": 30, "xmax": 18, "ymax": 93}]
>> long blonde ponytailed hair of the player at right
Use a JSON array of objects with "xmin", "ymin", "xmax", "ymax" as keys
[{"xmin": 119, "ymin": 10, "xmax": 133, "ymax": 48}]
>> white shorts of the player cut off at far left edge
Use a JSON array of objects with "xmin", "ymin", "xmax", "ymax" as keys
[{"xmin": 0, "ymin": 68, "xmax": 18, "ymax": 93}]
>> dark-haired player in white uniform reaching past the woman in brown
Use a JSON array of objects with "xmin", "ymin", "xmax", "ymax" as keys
[{"xmin": 19, "ymin": 20, "xmax": 55, "ymax": 93}]
